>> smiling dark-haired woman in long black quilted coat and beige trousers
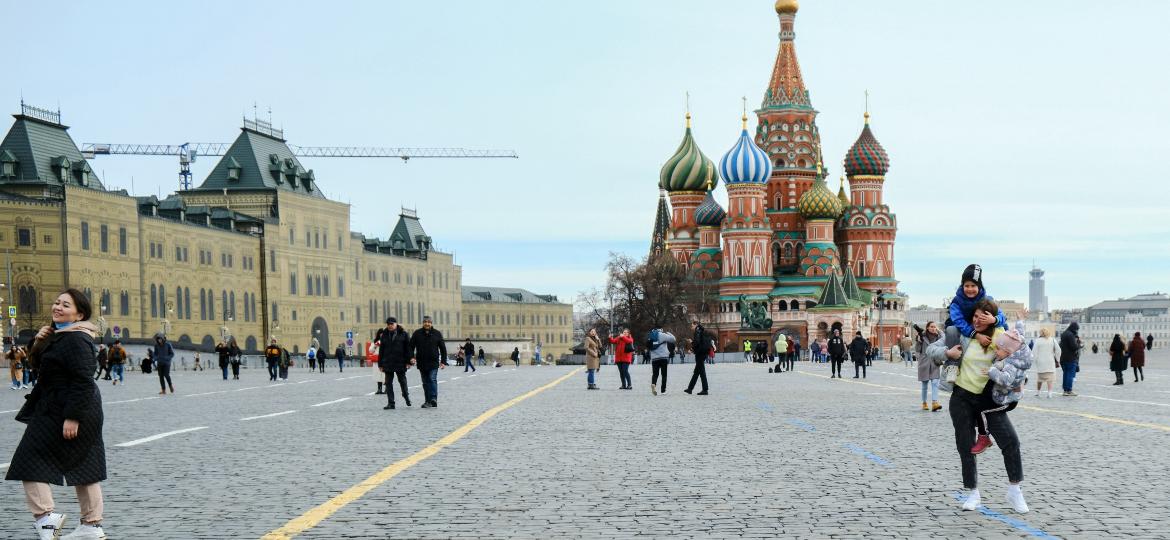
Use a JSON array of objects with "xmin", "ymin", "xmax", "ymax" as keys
[{"xmin": 5, "ymin": 289, "xmax": 106, "ymax": 539}]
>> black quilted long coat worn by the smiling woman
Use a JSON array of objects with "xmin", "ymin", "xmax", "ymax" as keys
[{"xmin": 6, "ymin": 323, "xmax": 105, "ymax": 485}]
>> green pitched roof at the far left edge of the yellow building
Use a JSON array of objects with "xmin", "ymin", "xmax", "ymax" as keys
[{"xmin": 0, "ymin": 115, "xmax": 105, "ymax": 189}]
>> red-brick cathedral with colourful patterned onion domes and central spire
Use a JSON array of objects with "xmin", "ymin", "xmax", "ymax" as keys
[{"xmin": 651, "ymin": 0, "xmax": 906, "ymax": 349}]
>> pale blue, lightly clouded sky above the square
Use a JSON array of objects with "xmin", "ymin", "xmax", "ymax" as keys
[{"xmin": 0, "ymin": 0, "xmax": 1170, "ymax": 309}]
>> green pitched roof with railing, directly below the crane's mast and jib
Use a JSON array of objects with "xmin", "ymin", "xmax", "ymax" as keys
[{"xmin": 195, "ymin": 127, "xmax": 325, "ymax": 199}]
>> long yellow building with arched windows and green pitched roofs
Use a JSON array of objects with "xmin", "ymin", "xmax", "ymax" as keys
[{"xmin": 0, "ymin": 104, "xmax": 462, "ymax": 352}]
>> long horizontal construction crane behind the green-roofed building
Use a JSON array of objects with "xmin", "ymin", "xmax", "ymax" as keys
[{"xmin": 81, "ymin": 120, "xmax": 519, "ymax": 189}]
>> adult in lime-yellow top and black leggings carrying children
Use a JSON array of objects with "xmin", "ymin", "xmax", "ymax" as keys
[{"xmin": 927, "ymin": 298, "xmax": 1028, "ymax": 513}]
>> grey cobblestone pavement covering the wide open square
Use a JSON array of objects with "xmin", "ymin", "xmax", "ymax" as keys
[{"xmin": 0, "ymin": 355, "xmax": 1170, "ymax": 539}]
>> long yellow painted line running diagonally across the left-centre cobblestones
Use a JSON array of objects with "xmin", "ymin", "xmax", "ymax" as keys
[{"xmin": 261, "ymin": 368, "xmax": 581, "ymax": 540}]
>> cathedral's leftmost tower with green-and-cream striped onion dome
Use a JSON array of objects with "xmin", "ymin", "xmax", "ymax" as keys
[{"xmin": 659, "ymin": 112, "xmax": 716, "ymax": 264}]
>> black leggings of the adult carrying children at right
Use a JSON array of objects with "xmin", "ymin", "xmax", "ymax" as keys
[{"xmin": 950, "ymin": 385, "xmax": 1024, "ymax": 490}]
